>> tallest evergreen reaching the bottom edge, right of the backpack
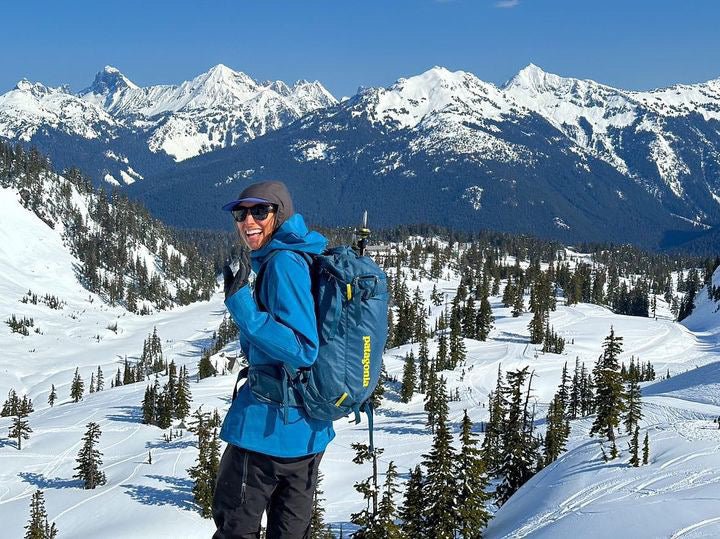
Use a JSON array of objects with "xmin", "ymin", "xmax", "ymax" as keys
[{"xmin": 423, "ymin": 378, "xmax": 457, "ymax": 539}]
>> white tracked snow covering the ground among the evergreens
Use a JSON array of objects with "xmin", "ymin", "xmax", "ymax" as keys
[{"xmin": 0, "ymin": 189, "xmax": 720, "ymax": 539}]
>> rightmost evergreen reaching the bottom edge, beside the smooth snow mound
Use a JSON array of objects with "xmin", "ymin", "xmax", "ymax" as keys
[{"xmin": 456, "ymin": 410, "xmax": 490, "ymax": 539}]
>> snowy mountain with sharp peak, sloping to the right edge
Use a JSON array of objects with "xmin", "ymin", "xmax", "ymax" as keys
[{"xmin": 503, "ymin": 64, "xmax": 720, "ymax": 223}]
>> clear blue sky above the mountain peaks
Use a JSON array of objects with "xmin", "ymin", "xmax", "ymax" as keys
[{"xmin": 0, "ymin": 0, "xmax": 720, "ymax": 97}]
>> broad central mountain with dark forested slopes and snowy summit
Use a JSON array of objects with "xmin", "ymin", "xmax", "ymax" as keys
[{"xmin": 138, "ymin": 67, "xmax": 720, "ymax": 247}]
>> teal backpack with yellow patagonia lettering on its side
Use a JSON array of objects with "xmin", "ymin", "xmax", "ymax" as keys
[{"xmin": 238, "ymin": 246, "xmax": 388, "ymax": 447}]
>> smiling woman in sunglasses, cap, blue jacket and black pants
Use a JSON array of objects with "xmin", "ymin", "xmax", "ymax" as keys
[{"xmin": 213, "ymin": 182, "xmax": 335, "ymax": 539}]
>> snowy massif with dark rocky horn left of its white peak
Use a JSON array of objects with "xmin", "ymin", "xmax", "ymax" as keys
[{"xmin": 79, "ymin": 64, "xmax": 336, "ymax": 161}]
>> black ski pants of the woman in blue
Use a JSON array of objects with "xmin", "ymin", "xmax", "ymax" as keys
[{"xmin": 212, "ymin": 444, "xmax": 323, "ymax": 539}]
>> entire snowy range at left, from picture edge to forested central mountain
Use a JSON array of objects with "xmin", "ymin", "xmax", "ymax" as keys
[{"xmin": 0, "ymin": 65, "xmax": 336, "ymax": 184}]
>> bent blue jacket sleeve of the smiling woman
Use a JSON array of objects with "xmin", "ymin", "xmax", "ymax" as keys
[{"xmin": 225, "ymin": 251, "xmax": 319, "ymax": 368}]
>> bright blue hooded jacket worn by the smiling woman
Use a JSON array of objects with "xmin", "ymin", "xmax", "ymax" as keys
[{"xmin": 220, "ymin": 214, "xmax": 335, "ymax": 457}]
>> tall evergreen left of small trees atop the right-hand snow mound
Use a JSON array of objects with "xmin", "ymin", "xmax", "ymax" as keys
[{"xmin": 590, "ymin": 327, "xmax": 625, "ymax": 451}]
